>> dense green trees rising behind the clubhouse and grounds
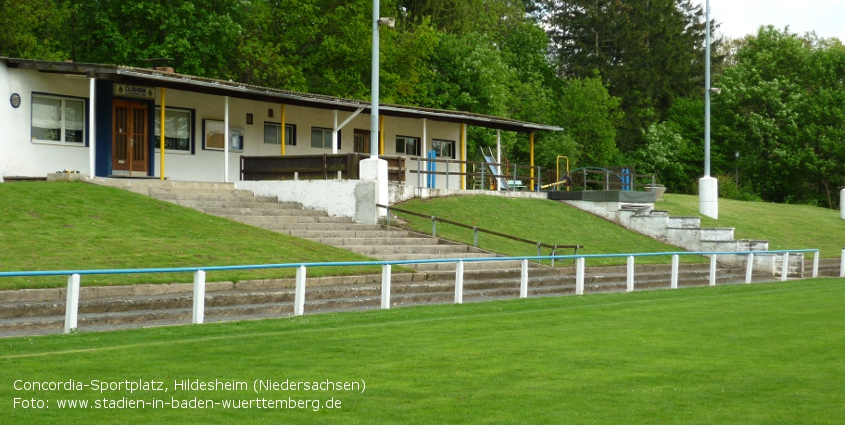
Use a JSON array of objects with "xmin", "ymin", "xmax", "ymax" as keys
[{"xmin": 0, "ymin": 0, "xmax": 845, "ymax": 207}]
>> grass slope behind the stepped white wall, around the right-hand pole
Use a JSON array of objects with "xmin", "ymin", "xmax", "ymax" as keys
[{"xmin": 654, "ymin": 194, "xmax": 845, "ymax": 258}]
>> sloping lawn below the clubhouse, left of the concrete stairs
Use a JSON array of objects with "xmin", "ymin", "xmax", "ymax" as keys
[{"xmin": 0, "ymin": 182, "xmax": 380, "ymax": 289}]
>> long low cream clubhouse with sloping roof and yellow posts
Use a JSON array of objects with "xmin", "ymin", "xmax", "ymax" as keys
[{"xmin": 0, "ymin": 58, "xmax": 560, "ymax": 189}]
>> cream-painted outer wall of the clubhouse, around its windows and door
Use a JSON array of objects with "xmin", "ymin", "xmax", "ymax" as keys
[{"xmin": 0, "ymin": 62, "xmax": 460, "ymax": 188}]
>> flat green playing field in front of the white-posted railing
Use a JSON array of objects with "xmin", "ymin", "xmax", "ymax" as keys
[{"xmin": 0, "ymin": 279, "xmax": 845, "ymax": 425}]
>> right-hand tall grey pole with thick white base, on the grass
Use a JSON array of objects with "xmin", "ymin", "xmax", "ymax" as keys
[{"xmin": 698, "ymin": 0, "xmax": 719, "ymax": 219}]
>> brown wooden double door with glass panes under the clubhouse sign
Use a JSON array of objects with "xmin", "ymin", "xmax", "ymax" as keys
[{"xmin": 112, "ymin": 100, "xmax": 150, "ymax": 175}]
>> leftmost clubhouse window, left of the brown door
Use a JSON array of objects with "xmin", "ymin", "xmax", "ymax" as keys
[{"xmin": 32, "ymin": 94, "xmax": 85, "ymax": 145}]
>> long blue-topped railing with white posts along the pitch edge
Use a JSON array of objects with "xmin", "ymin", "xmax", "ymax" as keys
[{"xmin": 0, "ymin": 249, "xmax": 824, "ymax": 333}]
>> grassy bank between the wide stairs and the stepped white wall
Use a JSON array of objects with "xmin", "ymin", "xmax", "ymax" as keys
[{"xmin": 396, "ymin": 195, "xmax": 699, "ymax": 265}]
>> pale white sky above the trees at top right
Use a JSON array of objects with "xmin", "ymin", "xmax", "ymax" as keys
[{"xmin": 693, "ymin": 0, "xmax": 845, "ymax": 42}]
